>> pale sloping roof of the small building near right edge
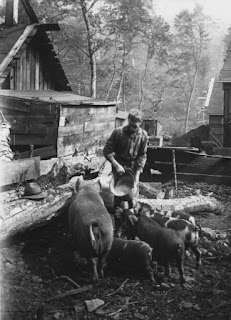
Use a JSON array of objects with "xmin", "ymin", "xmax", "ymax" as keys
[{"xmin": 207, "ymin": 79, "xmax": 224, "ymax": 115}]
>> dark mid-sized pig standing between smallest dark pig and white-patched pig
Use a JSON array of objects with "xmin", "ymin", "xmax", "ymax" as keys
[{"xmin": 125, "ymin": 212, "xmax": 185, "ymax": 283}]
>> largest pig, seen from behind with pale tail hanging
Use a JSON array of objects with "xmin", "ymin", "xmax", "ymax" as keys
[{"xmin": 68, "ymin": 179, "xmax": 113, "ymax": 280}]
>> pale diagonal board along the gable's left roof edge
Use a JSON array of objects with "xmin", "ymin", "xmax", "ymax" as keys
[{"xmin": 0, "ymin": 24, "xmax": 35, "ymax": 76}]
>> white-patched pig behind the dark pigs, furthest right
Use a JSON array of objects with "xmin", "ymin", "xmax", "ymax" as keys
[{"xmin": 139, "ymin": 204, "xmax": 201, "ymax": 268}]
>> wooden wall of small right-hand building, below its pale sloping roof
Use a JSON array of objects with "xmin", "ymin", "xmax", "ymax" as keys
[{"xmin": 209, "ymin": 115, "xmax": 224, "ymax": 147}]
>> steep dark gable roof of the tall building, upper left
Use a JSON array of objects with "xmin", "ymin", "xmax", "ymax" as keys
[{"xmin": 0, "ymin": 23, "xmax": 71, "ymax": 90}]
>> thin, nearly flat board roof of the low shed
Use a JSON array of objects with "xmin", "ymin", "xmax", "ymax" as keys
[{"xmin": 0, "ymin": 90, "xmax": 116, "ymax": 106}]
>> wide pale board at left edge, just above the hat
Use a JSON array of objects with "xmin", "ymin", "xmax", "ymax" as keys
[{"xmin": 0, "ymin": 157, "xmax": 40, "ymax": 187}]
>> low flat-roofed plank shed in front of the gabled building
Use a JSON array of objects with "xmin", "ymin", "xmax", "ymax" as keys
[{"xmin": 0, "ymin": 90, "xmax": 116, "ymax": 159}]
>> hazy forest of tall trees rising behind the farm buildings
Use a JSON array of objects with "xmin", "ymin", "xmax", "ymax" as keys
[{"xmin": 0, "ymin": 0, "xmax": 231, "ymax": 135}]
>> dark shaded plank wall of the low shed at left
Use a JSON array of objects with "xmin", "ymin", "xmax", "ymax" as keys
[{"xmin": 0, "ymin": 97, "xmax": 59, "ymax": 148}]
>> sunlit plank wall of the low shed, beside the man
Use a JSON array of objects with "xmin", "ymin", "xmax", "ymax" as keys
[{"xmin": 57, "ymin": 106, "xmax": 115, "ymax": 157}]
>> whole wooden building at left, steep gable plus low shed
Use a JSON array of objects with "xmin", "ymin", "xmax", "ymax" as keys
[{"xmin": 0, "ymin": 0, "xmax": 116, "ymax": 159}]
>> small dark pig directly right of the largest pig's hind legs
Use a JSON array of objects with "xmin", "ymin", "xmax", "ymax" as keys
[{"xmin": 109, "ymin": 238, "xmax": 155, "ymax": 284}]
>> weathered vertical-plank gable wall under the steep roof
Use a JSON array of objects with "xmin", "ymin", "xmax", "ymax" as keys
[{"xmin": 2, "ymin": 45, "xmax": 55, "ymax": 90}]
